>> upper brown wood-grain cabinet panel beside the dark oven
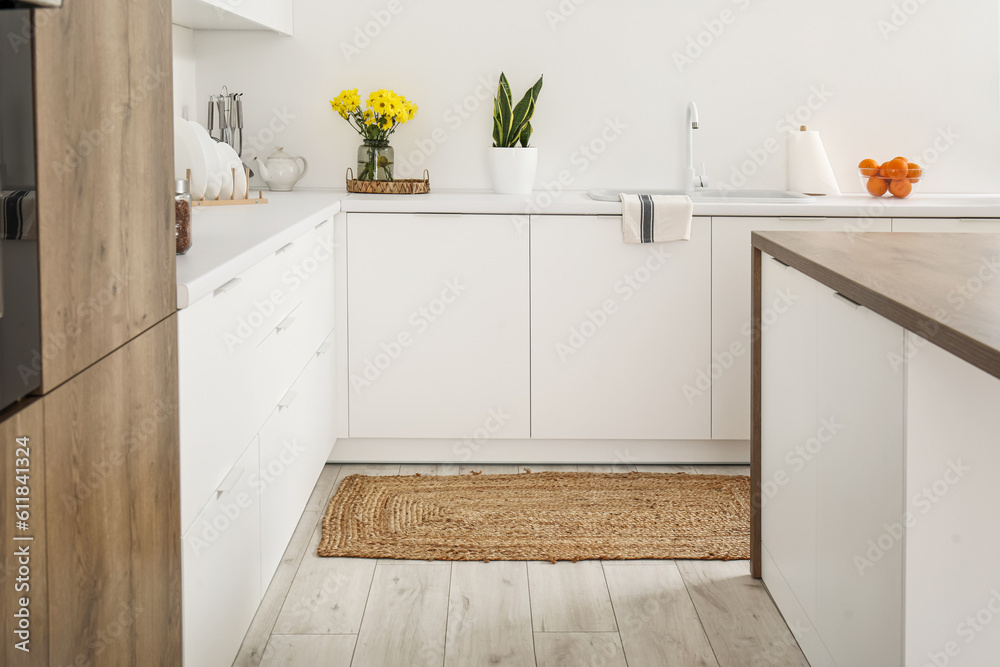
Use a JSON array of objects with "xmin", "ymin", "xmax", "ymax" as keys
[{"xmin": 35, "ymin": 0, "xmax": 176, "ymax": 392}]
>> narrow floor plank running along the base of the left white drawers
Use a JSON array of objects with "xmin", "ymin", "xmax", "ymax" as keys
[{"xmin": 233, "ymin": 511, "xmax": 320, "ymax": 667}]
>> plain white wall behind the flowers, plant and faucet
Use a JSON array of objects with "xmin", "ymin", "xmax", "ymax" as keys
[{"xmin": 186, "ymin": 0, "xmax": 1000, "ymax": 192}]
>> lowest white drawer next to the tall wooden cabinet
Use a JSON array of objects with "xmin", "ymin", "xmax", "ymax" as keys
[{"xmin": 182, "ymin": 439, "xmax": 263, "ymax": 667}]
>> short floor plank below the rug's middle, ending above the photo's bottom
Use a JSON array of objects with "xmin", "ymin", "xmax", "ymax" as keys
[{"xmin": 528, "ymin": 560, "xmax": 618, "ymax": 632}]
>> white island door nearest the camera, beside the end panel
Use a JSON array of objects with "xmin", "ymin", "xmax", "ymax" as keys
[{"xmin": 816, "ymin": 285, "xmax": 905, "ymax": 667}]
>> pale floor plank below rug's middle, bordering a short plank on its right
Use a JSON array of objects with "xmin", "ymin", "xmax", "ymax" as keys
[{"xmin": 444, "ymin": 561, "xmax": 535, "ymax": 667}]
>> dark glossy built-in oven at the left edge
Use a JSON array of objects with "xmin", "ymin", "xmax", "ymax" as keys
[{"xmin": 0, "ymin": 7, "xmax": 42, "ymax": 410}]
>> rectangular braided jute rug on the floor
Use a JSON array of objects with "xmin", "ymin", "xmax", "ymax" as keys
[{"xmin": 319, "ymin": 472, "xmax": 750, "ymax": 562}]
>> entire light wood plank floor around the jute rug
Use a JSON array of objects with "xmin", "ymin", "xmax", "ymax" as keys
[{"xmin": 234, "ymin": 464, "xmax": 808, "ymax": 667}]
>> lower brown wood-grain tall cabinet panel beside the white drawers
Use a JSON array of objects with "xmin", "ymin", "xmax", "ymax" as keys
[{"xmin": 39, "ymin": 316, "xmax": 181, "ymax": 665}]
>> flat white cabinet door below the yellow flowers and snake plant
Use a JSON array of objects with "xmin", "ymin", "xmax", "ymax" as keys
[{"xmin": 347, "ymin": 213, "xmax": 530, "ymax": 438}]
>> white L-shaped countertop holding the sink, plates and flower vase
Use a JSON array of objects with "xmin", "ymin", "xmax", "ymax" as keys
[{"xmin": 177, "ymin": 189, "xmax": 1000, "ymax": 308}]
